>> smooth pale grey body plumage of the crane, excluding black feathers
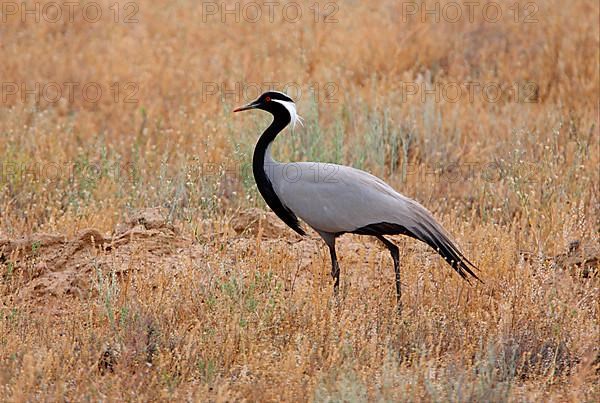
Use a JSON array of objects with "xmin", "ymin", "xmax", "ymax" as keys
[{"xmin": 266, "ymin": 160, "xmax": 439, "ymax": 234}]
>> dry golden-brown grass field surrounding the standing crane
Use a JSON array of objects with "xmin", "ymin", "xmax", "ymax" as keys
[{"xmin": 0, "ymin": 0, "xmax": 600, "ymax": 401}]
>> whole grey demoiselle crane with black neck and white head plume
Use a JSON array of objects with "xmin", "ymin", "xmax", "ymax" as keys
[{"xmin": 234, "ymin": 91, "xmax": 479, "ymax": 309}]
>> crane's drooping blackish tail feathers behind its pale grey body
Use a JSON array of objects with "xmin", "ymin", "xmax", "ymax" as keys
[{"xmin": 352, "ymin": 202, "xmax": 482, "ymax": 282}]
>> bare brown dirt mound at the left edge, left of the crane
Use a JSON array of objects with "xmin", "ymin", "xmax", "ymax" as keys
[{"xmin": 0, "ymin": 209, "xmax": 190, "ymax": 313}]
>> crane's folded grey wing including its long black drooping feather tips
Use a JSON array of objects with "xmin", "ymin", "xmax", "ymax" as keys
[{"xmin": 273, "ymin": 163, "xmax": 479, "ymax": 280}]
